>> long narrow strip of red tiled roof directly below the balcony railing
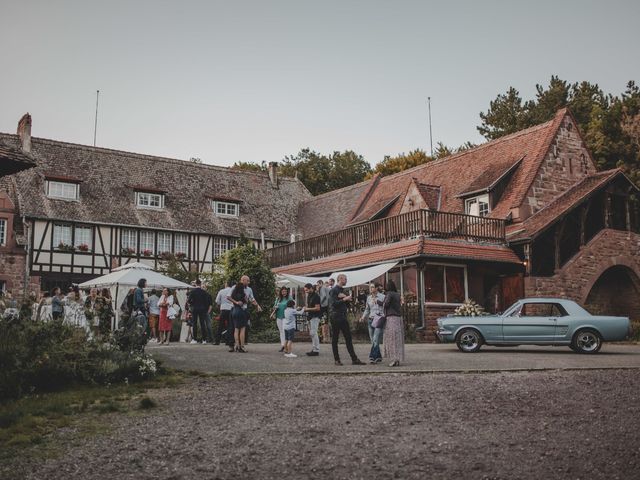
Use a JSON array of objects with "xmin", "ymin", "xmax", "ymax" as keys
[{"xmin": 273, "ymin": 238, "xmax": 521, "ymax": 275}]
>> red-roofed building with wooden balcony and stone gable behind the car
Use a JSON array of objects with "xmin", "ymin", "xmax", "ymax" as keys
[{"xmin": 268, "ymin": 109, "xmax": 640, "ymax": 333}]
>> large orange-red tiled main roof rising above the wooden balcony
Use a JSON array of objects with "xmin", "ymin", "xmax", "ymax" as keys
[{"xmin": 298, "ymin": 109, "xmax": 568, "ymax": 238}]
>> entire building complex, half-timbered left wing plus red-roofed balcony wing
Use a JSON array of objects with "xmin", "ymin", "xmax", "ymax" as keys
[{"xmin": 0, "ymin": 109, "xmax": 640, "ymax": 338}]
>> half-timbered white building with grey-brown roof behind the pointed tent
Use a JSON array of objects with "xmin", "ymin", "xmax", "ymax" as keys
[{"xmin": 0, "ymin": 116, "xmax": 311, "ymax": 293}]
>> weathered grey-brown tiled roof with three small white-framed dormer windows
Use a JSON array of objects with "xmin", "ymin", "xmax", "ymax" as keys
[{"xmin": 0, "ymin": 134, "xmax": 311, "ymax": 241}]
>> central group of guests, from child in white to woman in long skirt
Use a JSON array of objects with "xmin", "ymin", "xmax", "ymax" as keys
[{"xmin": 271, "ymin": 274, "xmax": 405, "ymax": 367}]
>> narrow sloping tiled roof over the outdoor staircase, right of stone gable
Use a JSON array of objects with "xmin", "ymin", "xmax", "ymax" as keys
[{"xmin": 507, "ymin": 169, "xmax": 624, "ymax": 242}]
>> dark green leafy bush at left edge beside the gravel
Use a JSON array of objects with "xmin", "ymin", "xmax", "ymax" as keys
[{"xmin": 0, "ymin": 318, "xmax": 157, "ymax": 400}]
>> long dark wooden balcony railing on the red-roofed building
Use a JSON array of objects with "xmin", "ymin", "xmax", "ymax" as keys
[{"xmin": 266, "ymin": 210, "xmax": 505, "ymax": 267}]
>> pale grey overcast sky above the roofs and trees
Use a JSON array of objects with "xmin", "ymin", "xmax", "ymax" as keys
[{"xmin": 0, "ymin": 0, "xmax": 640, "ymax": 165}]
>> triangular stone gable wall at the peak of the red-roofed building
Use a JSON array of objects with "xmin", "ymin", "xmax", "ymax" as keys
[{"xmin": 525, "ymin": 116, "xmax": 596, "ymax": 214}]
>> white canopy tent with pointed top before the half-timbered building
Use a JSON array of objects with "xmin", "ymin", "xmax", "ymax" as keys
[{"xmin": 79, "ymin": 262, "xmax": 192, "ymax": 325}]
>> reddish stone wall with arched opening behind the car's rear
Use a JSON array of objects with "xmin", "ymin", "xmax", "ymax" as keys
[{"xmin": 525, "ymin": 229, "xmax": 640, "ymax": 318}]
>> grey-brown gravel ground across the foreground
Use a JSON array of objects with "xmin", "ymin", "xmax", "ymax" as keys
[{"xmin": 8, "ymin": 370, "xmax": 640, "ymax": 480}]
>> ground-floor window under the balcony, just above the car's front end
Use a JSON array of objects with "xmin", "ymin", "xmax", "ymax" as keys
[{"xmin": 425, "ymin": 264, "xmax": 467, "ymax": 303}]
